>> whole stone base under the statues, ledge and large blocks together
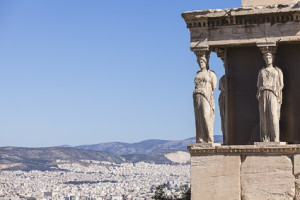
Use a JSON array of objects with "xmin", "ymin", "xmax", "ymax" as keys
[{"xmin": 188, "ymin": 144, "xmax": 300, "ymax": 200}]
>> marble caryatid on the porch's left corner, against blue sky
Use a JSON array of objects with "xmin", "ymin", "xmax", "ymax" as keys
[{"xmin": 193, "ymin": 56, "xmax": 217, "ymax": 143}]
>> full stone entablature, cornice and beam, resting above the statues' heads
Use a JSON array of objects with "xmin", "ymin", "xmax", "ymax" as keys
[{"xmin": 182, "ymin": 4, "xmax": 300, "ymax": 48}]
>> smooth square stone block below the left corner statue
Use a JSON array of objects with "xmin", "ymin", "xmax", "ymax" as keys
[{"xmin": 191, "ymin": 155, "xmax": 241, "ymax": 200}]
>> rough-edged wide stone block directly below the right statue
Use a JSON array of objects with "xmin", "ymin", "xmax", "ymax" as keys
[{"xmin": 241, "ymin": 156, "xmax": 295, "ymax": 200}]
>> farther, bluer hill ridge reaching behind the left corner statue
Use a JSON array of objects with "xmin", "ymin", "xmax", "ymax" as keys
[{"xmin": 76, "ymin": 135, "xmax": 223, "ymax": 155}]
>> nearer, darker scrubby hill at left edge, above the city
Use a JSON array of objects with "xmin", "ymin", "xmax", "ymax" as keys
[{"xmin": 0, "ymin": 147, "xmax": 125, "ymax": 171}]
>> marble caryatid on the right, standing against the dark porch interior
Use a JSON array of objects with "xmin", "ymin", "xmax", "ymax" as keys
[{"xmin": 257, "ymin": 52, "xmax": 283, "ymax": 142}]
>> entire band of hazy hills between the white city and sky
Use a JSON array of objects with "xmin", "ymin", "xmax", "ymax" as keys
[{"xmin": 0, "ymin": 136, "xmax": 222, "ymax": 171}]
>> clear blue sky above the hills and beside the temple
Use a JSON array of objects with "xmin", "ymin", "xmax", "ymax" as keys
[{"xmin": 0, "ymin": 0, "xmax": 240, "ymax": 147}]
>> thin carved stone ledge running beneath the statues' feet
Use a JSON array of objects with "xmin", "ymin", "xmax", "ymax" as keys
[{"xmin": 188, "ymin": 144, "xmax": 300, "ymax": 156}]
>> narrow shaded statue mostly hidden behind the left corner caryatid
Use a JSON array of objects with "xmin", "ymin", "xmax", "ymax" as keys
[{"xmin": 219, "ymin": 75, "xmax": 227, "ymax": 144}]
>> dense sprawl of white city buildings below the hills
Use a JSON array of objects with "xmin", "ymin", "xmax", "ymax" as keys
[{"xmin": 0, "ymin": 161, "xmax": 190, "ymax": 200}]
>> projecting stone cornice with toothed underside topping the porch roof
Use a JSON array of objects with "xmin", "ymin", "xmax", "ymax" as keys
[{"xmin": 182, "ymin": 4, "xmax": 300, "ymax": 29}]
